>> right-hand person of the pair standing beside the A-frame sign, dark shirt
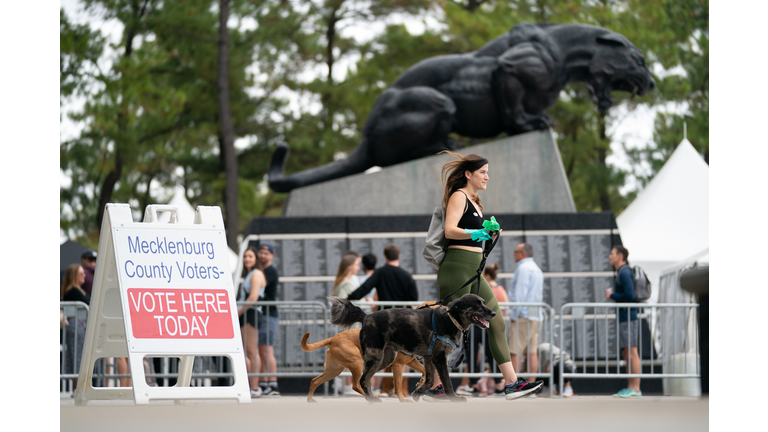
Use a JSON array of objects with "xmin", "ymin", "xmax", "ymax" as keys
[{"xmin": 257, "ymin": 243, "xmax": 280, "ymax": 396}]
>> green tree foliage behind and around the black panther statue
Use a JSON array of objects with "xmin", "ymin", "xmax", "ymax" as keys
[{"xmin": 60, "ymin": 0, "xmax": 709, "ymax": 246}]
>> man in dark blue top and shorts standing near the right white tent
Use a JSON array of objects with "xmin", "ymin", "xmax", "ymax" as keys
[{"xmin": 605, "ymin": 246, "xmax": 643, "ymax": 398}]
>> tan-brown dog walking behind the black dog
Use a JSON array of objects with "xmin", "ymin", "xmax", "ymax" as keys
[{"xmin": 301, "ymin": 328, "xmax": 424, "ymax": 402}]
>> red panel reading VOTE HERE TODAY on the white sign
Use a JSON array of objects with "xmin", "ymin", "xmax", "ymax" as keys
[{"xmin": 128, "ymin": 288, "xmax": 234, "ymax": 339}]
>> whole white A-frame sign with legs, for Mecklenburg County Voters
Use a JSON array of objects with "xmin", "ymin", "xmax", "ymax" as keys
[{"xmin": 75, "ymin": 204, "xmax": 250, "ymax": 405}]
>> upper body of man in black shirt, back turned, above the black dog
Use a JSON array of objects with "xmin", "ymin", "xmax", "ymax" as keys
[{"xmin": 347, "ymin": 243, "xmax": 419, "ymax": 309}]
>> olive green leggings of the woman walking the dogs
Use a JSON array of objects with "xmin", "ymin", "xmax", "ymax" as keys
[{"xmin": 437, "ymin": 249, "xmax": 510, "ymax": 364}]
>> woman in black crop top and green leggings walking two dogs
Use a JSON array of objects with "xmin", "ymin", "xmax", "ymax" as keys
[{"xmin": 425, "ymin": 151, "xmax": 543, "ymax": 400}]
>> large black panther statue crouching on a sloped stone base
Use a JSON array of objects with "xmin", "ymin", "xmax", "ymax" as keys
[{"xmin": 269, "ymin": 23, "xmax": 655, "ymax": 192}]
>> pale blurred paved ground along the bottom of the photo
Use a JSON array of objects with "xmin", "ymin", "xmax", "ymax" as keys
[{"xmin": 60, "ymin": 395, "xmax": 709, "ymax": 432}]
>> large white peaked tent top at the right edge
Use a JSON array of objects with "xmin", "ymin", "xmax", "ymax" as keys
[{"xmin": 616, "ymin": 138, "xmax": 709, "ymax": 302}]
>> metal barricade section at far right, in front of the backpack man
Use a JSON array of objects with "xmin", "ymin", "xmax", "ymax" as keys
[{"xmin": 557, "ymin": 303, "xmax": 700, "ymax": 396}]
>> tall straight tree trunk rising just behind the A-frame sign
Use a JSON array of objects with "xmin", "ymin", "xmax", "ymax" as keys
[{"xmin": 218, "ymin": 0, "xmax": 240, "ymax": 250}]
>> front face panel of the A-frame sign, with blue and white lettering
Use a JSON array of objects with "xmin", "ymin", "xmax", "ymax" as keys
[{"xmin": 112, "ymin": 228, "xmax": 242, "ymax": 353}]
